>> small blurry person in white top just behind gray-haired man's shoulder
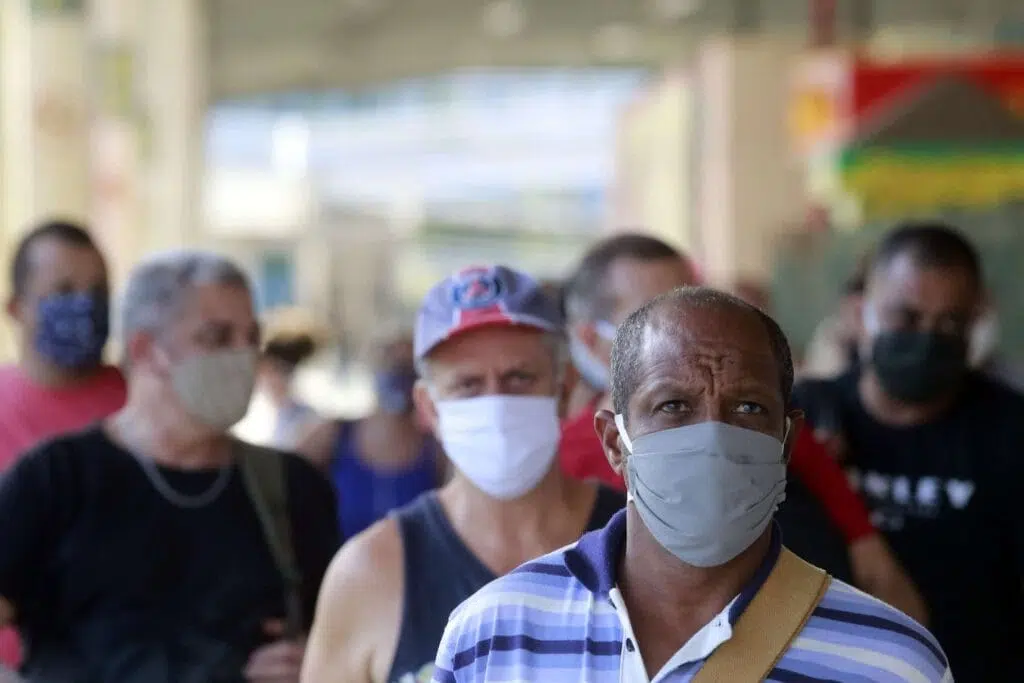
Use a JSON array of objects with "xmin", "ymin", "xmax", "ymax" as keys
[{"xmin": 260, "ymin": 333, "xmax": 319, "ymax": 451}]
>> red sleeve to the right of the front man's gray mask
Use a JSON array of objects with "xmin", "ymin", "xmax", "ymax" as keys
[{"xmin": 790, "ymin": 427, "xmax": 874, "ymax": 544}]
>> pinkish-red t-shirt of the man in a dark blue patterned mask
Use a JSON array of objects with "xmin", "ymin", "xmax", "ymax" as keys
[{"xmin": 0, "ymin": 366, "xmax": 127, "ymax": 667}]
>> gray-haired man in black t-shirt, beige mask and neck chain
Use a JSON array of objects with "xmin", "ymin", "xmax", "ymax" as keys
[{"xmin": 0, "ymin": 251, "xmax": 339, "ymax": 683}]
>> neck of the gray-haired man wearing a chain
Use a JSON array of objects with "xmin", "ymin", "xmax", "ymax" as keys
[{"xmin": 108, "ymin": 397, "xmax": 231, "ymax": 470}]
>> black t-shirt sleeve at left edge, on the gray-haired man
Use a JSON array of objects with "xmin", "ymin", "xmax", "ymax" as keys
[{"xmin": 0, "ymin": 442, "xmax": 68, "ymax": 611}]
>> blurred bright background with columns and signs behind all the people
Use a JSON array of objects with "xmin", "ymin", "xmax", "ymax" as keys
[{"xmin": 0, "ymin": 0, "xmax": 1024, "ymax": 437}]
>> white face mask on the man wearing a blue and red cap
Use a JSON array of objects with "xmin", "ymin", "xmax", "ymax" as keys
[{"xmin": 436, "ymin": 395, "xmax": 561, "ymax": 501}]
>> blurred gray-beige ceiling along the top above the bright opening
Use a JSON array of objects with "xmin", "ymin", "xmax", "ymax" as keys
[{"xmin": 207, "ymin": 0, "xmax": 1024, "ymax": 99}]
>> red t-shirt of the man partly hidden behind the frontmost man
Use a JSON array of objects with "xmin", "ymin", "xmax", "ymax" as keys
[{"xmin": 558, "ymin": 401, "xmax": 874, "ymax": 543}]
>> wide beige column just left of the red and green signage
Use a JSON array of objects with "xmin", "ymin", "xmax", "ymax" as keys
[{"xmin": 695, "ymin": 36, "xmax": 806, "ymax": 285}]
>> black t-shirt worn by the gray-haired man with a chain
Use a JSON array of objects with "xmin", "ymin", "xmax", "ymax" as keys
[{"xmin": 0, "ymin": 427, "xmax": 340, "ymax": 683}]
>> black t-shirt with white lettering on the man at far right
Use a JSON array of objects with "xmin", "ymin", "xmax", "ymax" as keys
[{"xmin": 797, "ymin": 375, "xmax": 1024, "ymax": 683}]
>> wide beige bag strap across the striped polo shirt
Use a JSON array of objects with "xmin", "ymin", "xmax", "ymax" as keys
[{"xmin": 693, "ymin": 548, "xmax": 830, "ymax": 683}]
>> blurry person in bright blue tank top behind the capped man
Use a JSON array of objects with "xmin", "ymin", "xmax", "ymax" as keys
[{"xmin": 299, "ymin": 333, "xmax": 446, "ymax": 539}]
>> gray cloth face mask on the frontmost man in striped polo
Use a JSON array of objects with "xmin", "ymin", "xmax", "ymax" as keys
[{"xmin": 615, "ymin": 415, "xmax": 788, "ymax": 567}]
